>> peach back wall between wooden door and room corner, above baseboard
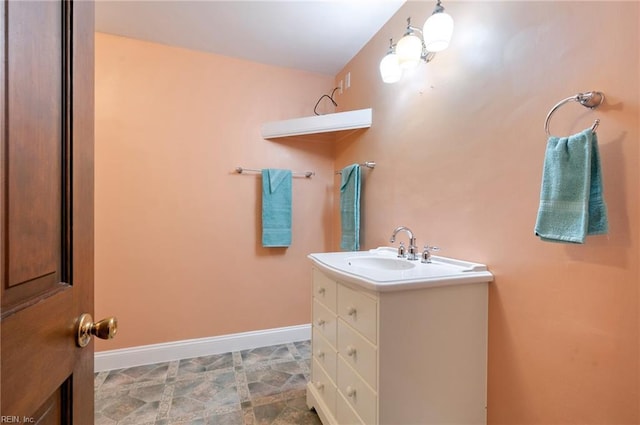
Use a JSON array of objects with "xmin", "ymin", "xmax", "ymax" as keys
[{"xmin": 95, "ymin": 34, "xmax": 333, "ymax": 351}]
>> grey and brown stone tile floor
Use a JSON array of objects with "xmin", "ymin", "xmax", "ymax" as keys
[{"xmin": 95, "ymin": 341, "xmax": 321, "ymax": 425}]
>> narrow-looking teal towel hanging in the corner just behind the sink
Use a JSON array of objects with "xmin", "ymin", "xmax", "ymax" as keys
[{"xmin": 340, "ymin": 164, "xmax": 360, "ymax": 251}]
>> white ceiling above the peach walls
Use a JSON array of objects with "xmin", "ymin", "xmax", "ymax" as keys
[{"xmin": 95, "ymin": 0, "xmax": 406, "ymax": 76}]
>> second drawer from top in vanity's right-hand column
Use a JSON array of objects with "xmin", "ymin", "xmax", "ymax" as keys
[{"xmin": 337, "ymin": 319, "xmax": 378, "ymax": 390}]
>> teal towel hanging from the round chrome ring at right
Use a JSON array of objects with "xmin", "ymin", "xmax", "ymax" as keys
[{"xmin": 535, "ymin": 128, "xmax": 609, "ymax": 243}]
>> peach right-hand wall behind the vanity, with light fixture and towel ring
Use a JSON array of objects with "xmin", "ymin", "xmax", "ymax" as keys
[{"xmin": 333, "ymin": 1, "xmax": 640, "ymax": 425}]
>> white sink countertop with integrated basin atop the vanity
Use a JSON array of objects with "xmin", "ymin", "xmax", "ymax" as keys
[{"xmin": 308, "ymin": 247, "xmax": 493, "ymax": 292}]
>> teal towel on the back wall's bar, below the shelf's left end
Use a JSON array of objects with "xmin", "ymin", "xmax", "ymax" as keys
[{"xmin": 262, "ymin": 169, "xmax": 292, "ymax": 247}]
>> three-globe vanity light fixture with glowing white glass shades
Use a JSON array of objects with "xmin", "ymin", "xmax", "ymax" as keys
[{"xmin": 380, "ymin": 0, "xmax": 453, "ymax": 83}]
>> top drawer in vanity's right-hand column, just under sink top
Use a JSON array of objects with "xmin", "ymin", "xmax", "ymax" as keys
[{"xmin": 338, "ymin": 285, "xmax": 378, "ymax": 344}]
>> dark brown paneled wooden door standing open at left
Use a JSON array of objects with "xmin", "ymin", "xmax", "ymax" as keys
[{"xmin": 0, "ymin": 0, "xmax": 94, "ymax": 425}]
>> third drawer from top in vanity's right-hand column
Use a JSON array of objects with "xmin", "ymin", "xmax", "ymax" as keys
[{"xmin": 338, "ymin": 356, "xmax": 377, "ymax": 425}]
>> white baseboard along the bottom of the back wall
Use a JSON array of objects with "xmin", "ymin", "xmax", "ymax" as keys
[{"xmin": 94, "ymin": 324, "xmax": 311, "ymax": 372}]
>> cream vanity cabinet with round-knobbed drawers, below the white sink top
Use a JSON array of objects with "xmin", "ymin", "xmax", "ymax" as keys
[{"xmin": 307, "ymin": 266, "xmax": 488, "ymax": 425}]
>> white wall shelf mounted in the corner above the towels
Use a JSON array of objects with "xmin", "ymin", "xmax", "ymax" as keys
[{"xmin": 262, "ymin": 108, "xmax": 372, "ymax": 139}]
